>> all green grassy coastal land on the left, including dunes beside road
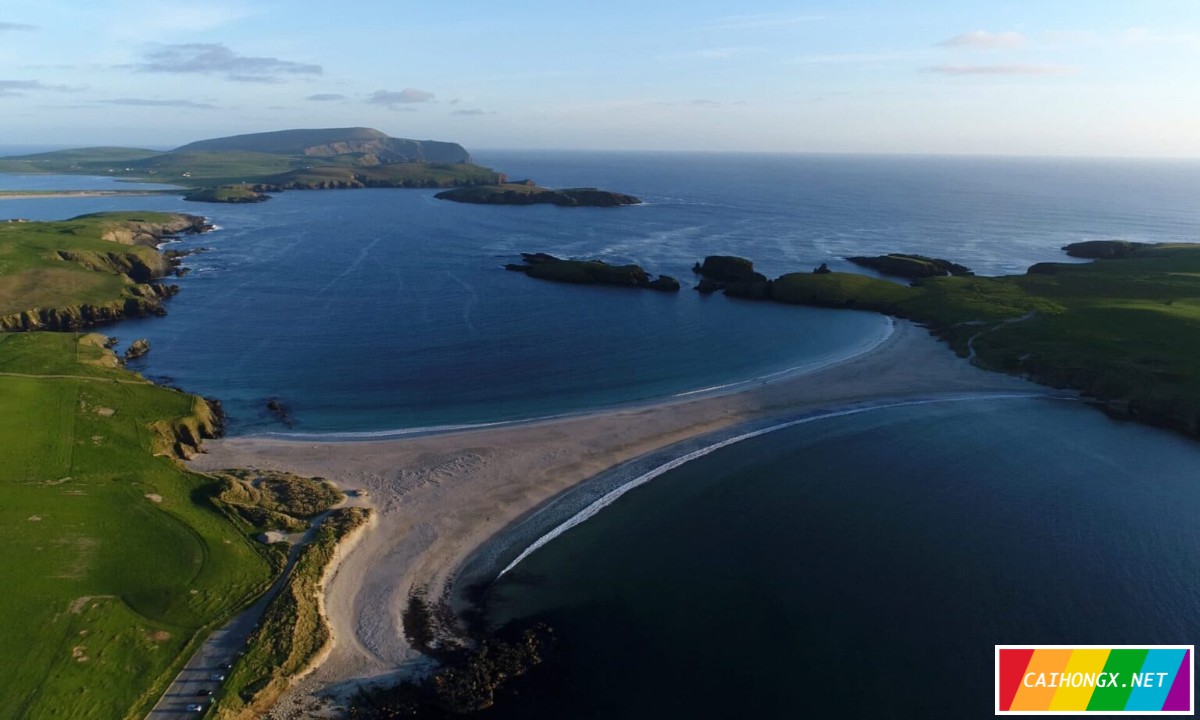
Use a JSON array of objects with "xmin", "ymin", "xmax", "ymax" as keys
[{"xmin": 0, "ymin": 212, "xmax": 368, "ymax": 720}]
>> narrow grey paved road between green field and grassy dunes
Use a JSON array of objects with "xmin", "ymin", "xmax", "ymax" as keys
[{"xmin": 146, "ymin": 503, "xmax": 333, "ymax": 720}]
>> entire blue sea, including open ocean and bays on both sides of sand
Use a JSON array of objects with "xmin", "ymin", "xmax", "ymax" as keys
[{"xmin": 0, "ymin": 151, "xmax": 1200, "ymax": 719}]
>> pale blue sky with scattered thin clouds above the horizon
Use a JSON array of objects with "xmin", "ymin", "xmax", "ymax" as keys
[{"xmin": 0, "ymin": 0, "xmax": 1200, "ymax": 157}]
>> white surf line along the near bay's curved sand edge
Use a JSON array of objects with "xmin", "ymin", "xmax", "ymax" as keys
[{"xmin": 496, "ymin": 392, "xmax": 1066, "ymax": 580}]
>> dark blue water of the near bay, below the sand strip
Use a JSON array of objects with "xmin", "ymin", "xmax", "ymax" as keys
[{"xmin": 490, "ymin": 400, "xmax": 1200, "ymax": 719}]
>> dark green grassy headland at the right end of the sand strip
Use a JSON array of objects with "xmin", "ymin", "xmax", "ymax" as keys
[{"xmin": 769, "ymin": 245, "xmax": 1200, "ymax": 436}]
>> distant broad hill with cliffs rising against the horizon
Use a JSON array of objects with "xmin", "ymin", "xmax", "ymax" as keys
[{"xmin": 173, "ymin": 127, "xmax": 470, "ymax": 166}]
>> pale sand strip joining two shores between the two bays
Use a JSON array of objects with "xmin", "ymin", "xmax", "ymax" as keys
[{"xmin": 182, "ymin": 320, "xmax": 1045, "ymax": 708}]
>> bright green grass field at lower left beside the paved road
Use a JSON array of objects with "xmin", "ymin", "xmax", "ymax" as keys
[{"xmin": 0, "ymin": 332, "xmax": 271, "ymax": 720}]
